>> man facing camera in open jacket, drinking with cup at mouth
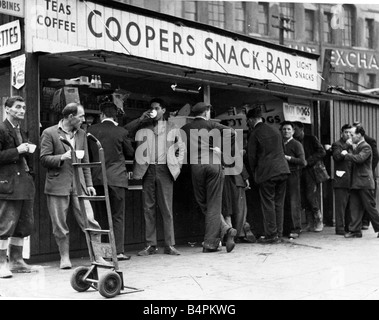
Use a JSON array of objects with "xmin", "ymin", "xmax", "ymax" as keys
[{"xmin": 125, "ymin": 98, "xmax": 185, "ymax": 256}]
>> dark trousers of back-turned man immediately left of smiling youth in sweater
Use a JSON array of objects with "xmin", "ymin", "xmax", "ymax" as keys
[{"xmin": 259, "ymin": 175, "xmax": 287, "ymax": 238}]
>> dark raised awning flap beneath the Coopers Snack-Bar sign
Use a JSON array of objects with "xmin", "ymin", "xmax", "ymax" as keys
[{"xmin": 40, "ymin": 50, "xmax": 368, "ymax": 101}]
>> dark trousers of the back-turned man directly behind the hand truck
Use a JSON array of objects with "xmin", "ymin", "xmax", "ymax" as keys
[{"xmin": 92, "ymin": 186, "xmax": 126, "ymax": 254}]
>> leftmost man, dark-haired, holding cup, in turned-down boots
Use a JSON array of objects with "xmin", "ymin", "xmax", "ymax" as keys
[{"xmin": 0, "ymin": 96, "xmax": 35, "ymax": 278}]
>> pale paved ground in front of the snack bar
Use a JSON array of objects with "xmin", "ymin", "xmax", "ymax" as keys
[{"xmin": 0, "ymin": 228, "xmax": 379, "ymax": 300}]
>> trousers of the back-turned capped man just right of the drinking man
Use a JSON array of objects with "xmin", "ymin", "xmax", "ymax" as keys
[{"xmin": 191, "ymin": 164, "xmax": 224, "ymax": 249}]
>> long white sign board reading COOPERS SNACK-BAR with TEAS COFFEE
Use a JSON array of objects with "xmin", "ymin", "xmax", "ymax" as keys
[{"xmin": 26, "ymin": 0, "xmax": 318, "ymax": 90}]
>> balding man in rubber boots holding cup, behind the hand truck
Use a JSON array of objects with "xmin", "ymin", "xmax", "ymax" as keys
[{"xmin": 40, "ymin": 103, "xmax": 106, "ymax": 269}]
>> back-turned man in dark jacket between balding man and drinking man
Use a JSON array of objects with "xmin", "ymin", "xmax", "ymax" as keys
[{"xmin": 88, "ymin": 102, "xmax": 134, "ymax": 260}]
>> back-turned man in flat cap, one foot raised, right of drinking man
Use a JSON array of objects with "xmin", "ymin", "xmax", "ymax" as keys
[{"xmin": 182, "ymin": 102, "xmax": 237, "ymax": 253}]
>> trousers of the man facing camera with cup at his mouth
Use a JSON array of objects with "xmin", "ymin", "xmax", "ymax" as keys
[{"xmin": 142, "ymin": 164, "xmax": 175, "ymax": 246}]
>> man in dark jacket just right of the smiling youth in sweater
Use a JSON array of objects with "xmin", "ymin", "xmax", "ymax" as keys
[{"xmin": 294, "ymin": 121, "xmax": 326, "ymax": 232}]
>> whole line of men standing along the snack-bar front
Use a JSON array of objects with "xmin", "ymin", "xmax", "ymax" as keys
[{"xmin": 0, "ymin": 97, "xmax": 379, "ymax": 278}]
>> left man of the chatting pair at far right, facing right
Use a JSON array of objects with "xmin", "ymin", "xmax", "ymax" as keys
[{"xmin": 332, "ymin": 124, "xmax": 353, "ymax": 235}]
